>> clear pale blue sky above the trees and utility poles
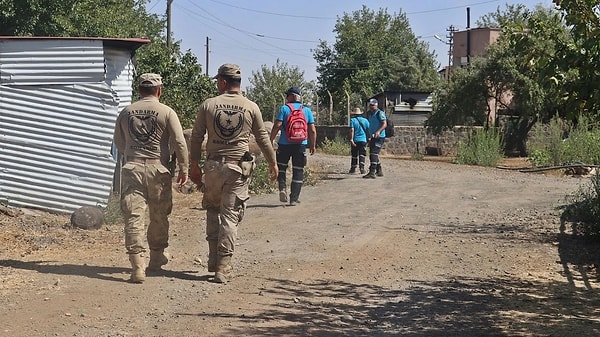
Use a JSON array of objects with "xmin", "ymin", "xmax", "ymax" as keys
[{"xmin": 147, "ymin": 0, "xmax": 553, "ymax": 86}]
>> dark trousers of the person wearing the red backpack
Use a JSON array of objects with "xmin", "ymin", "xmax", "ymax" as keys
[{"xmin": 277, "ymin": 144, "xmax": 306, "ymax": 202}]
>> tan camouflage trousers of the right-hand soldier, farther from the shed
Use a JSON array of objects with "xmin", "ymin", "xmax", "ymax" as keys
[{"xmin": 202, "ymin": 160, "xmax": 250, "ymax": 256}]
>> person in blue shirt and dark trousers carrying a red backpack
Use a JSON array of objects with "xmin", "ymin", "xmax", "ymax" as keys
[{"xmin": 271, "ymin": 87, "xmax": 317, "ymax": 206}]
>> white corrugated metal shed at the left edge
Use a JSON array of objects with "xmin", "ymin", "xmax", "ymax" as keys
[{"xmin": 0, "ymin": 37, "xmax": 149, "ymax": 213}]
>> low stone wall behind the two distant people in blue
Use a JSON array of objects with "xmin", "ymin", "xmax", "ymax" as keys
[{"xmin": 317, "ymin": 125, "xmax": 477, "ymax": 156}]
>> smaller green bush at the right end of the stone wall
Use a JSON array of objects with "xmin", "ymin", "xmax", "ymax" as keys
[{"xmin": 454, "ymin": 128, "xmax": 503, "ymax": 166}]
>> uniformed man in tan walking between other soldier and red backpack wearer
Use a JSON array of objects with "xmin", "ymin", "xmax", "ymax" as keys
[{"xmin": 190, "ymin": 63, "xmax": 277, "ymax": 283}]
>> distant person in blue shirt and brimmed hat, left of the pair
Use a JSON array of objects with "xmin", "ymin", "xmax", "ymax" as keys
[{"xmin": 348, "ymin": 108, "xmax": 371, "ymax": 174}]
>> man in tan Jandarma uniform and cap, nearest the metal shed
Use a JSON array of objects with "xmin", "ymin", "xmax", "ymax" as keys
[{"xmin": 114, "ymin": 73, "xmax": 188, "ymax": 283}]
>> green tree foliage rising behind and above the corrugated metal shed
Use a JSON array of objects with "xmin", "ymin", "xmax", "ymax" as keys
[{"xmin": 0, "ymin": 0, "xmax": 216, "ymax": 127}]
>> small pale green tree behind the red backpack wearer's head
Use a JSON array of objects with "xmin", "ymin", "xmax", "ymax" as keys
[{"xmin": 246, "ymin": 59, "xmax": 314, "ymax": 121}]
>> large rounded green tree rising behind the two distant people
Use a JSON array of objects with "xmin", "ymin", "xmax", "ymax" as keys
[{"xmin": 314, "ymin": 5, "xmax": 439, "ymax": 123}]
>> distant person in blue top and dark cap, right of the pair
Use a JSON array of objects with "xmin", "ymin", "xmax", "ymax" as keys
[{"xmin": 363, "ymin": 98, "xmax": 387, "ymax": 179}]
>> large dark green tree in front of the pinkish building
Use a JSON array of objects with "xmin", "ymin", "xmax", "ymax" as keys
[{"xmin": 427, "ymin": 6, "xmax": 572, "ymax": 154}]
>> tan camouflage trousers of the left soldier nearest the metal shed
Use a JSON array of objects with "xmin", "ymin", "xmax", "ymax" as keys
[{"xmin": 121, "ymin": 162, "xmax": 173, "ymax": 254}]
